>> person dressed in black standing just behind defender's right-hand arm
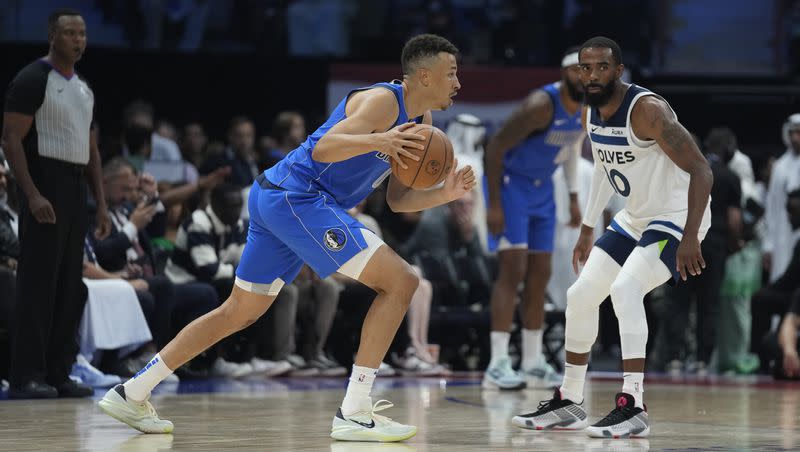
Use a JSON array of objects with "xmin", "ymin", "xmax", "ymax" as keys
[{"xmin": 662, "ymin": 137, "xmax": 743, "ymax": 374}]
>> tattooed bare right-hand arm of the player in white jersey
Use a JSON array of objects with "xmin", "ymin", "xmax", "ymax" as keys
[{"xmin": 631, "ymin": 96, "xmax": 714, "ymax": 280}]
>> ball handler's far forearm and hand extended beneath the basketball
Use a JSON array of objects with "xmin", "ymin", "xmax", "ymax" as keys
[{"xmin": 386, "ymin": 160, "xmax": 477, "ymax": 212}]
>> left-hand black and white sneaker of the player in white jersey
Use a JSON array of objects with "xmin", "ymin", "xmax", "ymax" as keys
[{"xmin": 511, "ymin": 388, "xmax": 589, "ymax": 430}]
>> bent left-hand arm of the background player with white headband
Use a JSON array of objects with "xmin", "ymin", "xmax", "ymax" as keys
[{"xmin": 486, "ymin": 90, "xmax": 553, "ymax": 234}]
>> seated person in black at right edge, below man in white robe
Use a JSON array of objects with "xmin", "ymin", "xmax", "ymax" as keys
[{"xmin": 750, "ymin": 189, "xmax": 800, "ymax": 372}]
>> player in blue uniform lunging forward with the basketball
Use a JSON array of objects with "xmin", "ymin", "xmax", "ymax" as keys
[{"xmin": 100, "ymin": 35, "xmax": 475, "ymax": 441}]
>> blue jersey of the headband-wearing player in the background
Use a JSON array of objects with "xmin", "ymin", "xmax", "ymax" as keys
[{"xmin": 503, "ymin": 82, "xmax": 583, "ymax": 183}]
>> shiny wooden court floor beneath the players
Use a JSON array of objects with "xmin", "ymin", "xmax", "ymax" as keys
[{"xmin": 0, "ymin": 379, "xmax": 800, "ymax": 452}]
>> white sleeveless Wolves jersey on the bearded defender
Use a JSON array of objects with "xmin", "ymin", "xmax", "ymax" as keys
[{"xmin": 586, "ymin": 84, "xmax": 711, "ymax": 240}]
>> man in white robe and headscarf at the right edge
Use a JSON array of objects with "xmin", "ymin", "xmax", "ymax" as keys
[{"xmin": 762, "ymin": 113, "xmax": 800, "ymax": 282}]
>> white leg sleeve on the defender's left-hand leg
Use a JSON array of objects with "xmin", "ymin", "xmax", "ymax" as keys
[{"xmin": 564, "ymin": 249, "xmax": 620, "ymax": 353}]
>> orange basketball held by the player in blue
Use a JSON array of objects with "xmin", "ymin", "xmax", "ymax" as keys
[{"xmin": 392, "ymin": 124, "xmax": 453, "ymax": 190}]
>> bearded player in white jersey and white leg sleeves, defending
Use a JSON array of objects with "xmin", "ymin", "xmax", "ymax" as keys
[{"xmin": 512, "ymin": 37, "xmax": 713, "ymax": 438}]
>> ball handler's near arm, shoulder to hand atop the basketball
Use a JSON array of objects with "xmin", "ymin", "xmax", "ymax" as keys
[{"xmin": 311, "ymin": 88, "xmax": 425, "ymax": 169}]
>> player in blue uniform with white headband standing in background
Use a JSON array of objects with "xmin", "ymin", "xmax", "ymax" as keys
[{"xmin": 483, "ymin": 47, "xmax": 584, "ymax": 389}]
